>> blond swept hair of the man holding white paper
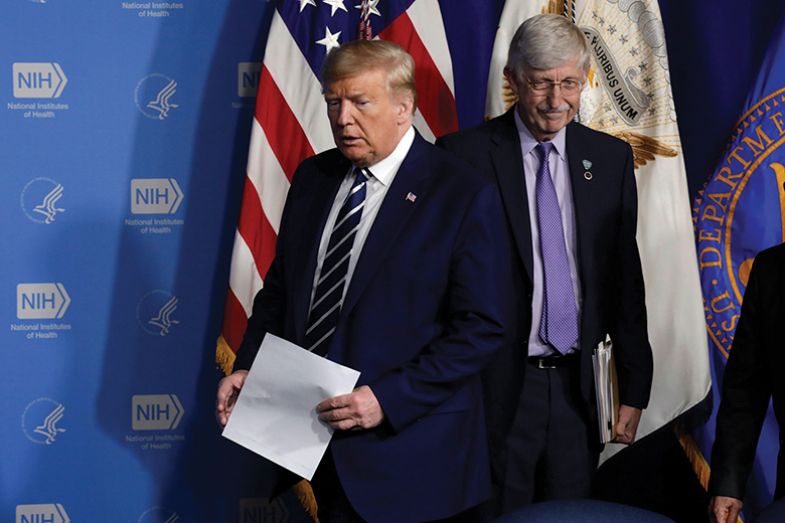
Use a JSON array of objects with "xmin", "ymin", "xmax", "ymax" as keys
[{"xmin": 322, "ymin": 40, "xmax": 417, "ymax": 104}]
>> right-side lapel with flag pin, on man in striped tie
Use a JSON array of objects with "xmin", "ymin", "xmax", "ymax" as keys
[{"xmin": 341, "ymin": 134, "xmax": 432, "ymax": 319}]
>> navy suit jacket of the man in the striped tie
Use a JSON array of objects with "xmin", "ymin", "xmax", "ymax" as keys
[{"xmin": 235, "ymin": 136, "xmax": 512, "ymax": 522}]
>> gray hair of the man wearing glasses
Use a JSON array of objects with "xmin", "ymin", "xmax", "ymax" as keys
[{"xmin": 507, "ymin": 14, "xmax": 591, "ymax": 76}]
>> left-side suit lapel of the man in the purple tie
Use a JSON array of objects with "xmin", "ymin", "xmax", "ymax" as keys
[{"xmin": 490, "ymin": 109, "xmax": 533, "ymax": 281}]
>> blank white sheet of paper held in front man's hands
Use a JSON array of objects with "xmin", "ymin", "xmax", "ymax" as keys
[{"xmin": 217, "ymin": 334, "xmax": 360, "ymax": 480}]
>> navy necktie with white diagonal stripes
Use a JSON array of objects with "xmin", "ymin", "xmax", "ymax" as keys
[{"xmin": 303, "ymin": 168, "xmax": 371, "ymax": 356}]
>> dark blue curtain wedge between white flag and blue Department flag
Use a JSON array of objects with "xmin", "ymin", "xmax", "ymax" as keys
[{"xmin": 660, "ymin": 0, "xmax": 785, "ymax": 197}]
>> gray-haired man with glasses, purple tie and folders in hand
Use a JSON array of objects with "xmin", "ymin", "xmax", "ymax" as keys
[{"xmin": 439, "ymin": 15, "xmax": 652, "ymax": 512}]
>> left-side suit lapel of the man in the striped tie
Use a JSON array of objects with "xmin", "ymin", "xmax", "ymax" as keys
[{"xmin": 290, "ymin": 155, "xmax": 351, "ymax": 341}]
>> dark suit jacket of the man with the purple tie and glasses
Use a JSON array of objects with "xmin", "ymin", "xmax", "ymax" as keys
[{"xmin": 437, "ymin": 109, "xmax": 652, "ymax": 458}]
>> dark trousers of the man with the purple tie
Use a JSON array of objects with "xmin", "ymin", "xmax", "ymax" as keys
[{"xmin": 500, "ymin": 355, "xmax": 600, "ymax": 512}]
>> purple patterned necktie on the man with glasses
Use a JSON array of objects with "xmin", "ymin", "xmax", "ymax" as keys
[{"xmin": 535, "ymin": 142, "xmax": 578, "ymax": 354}]
